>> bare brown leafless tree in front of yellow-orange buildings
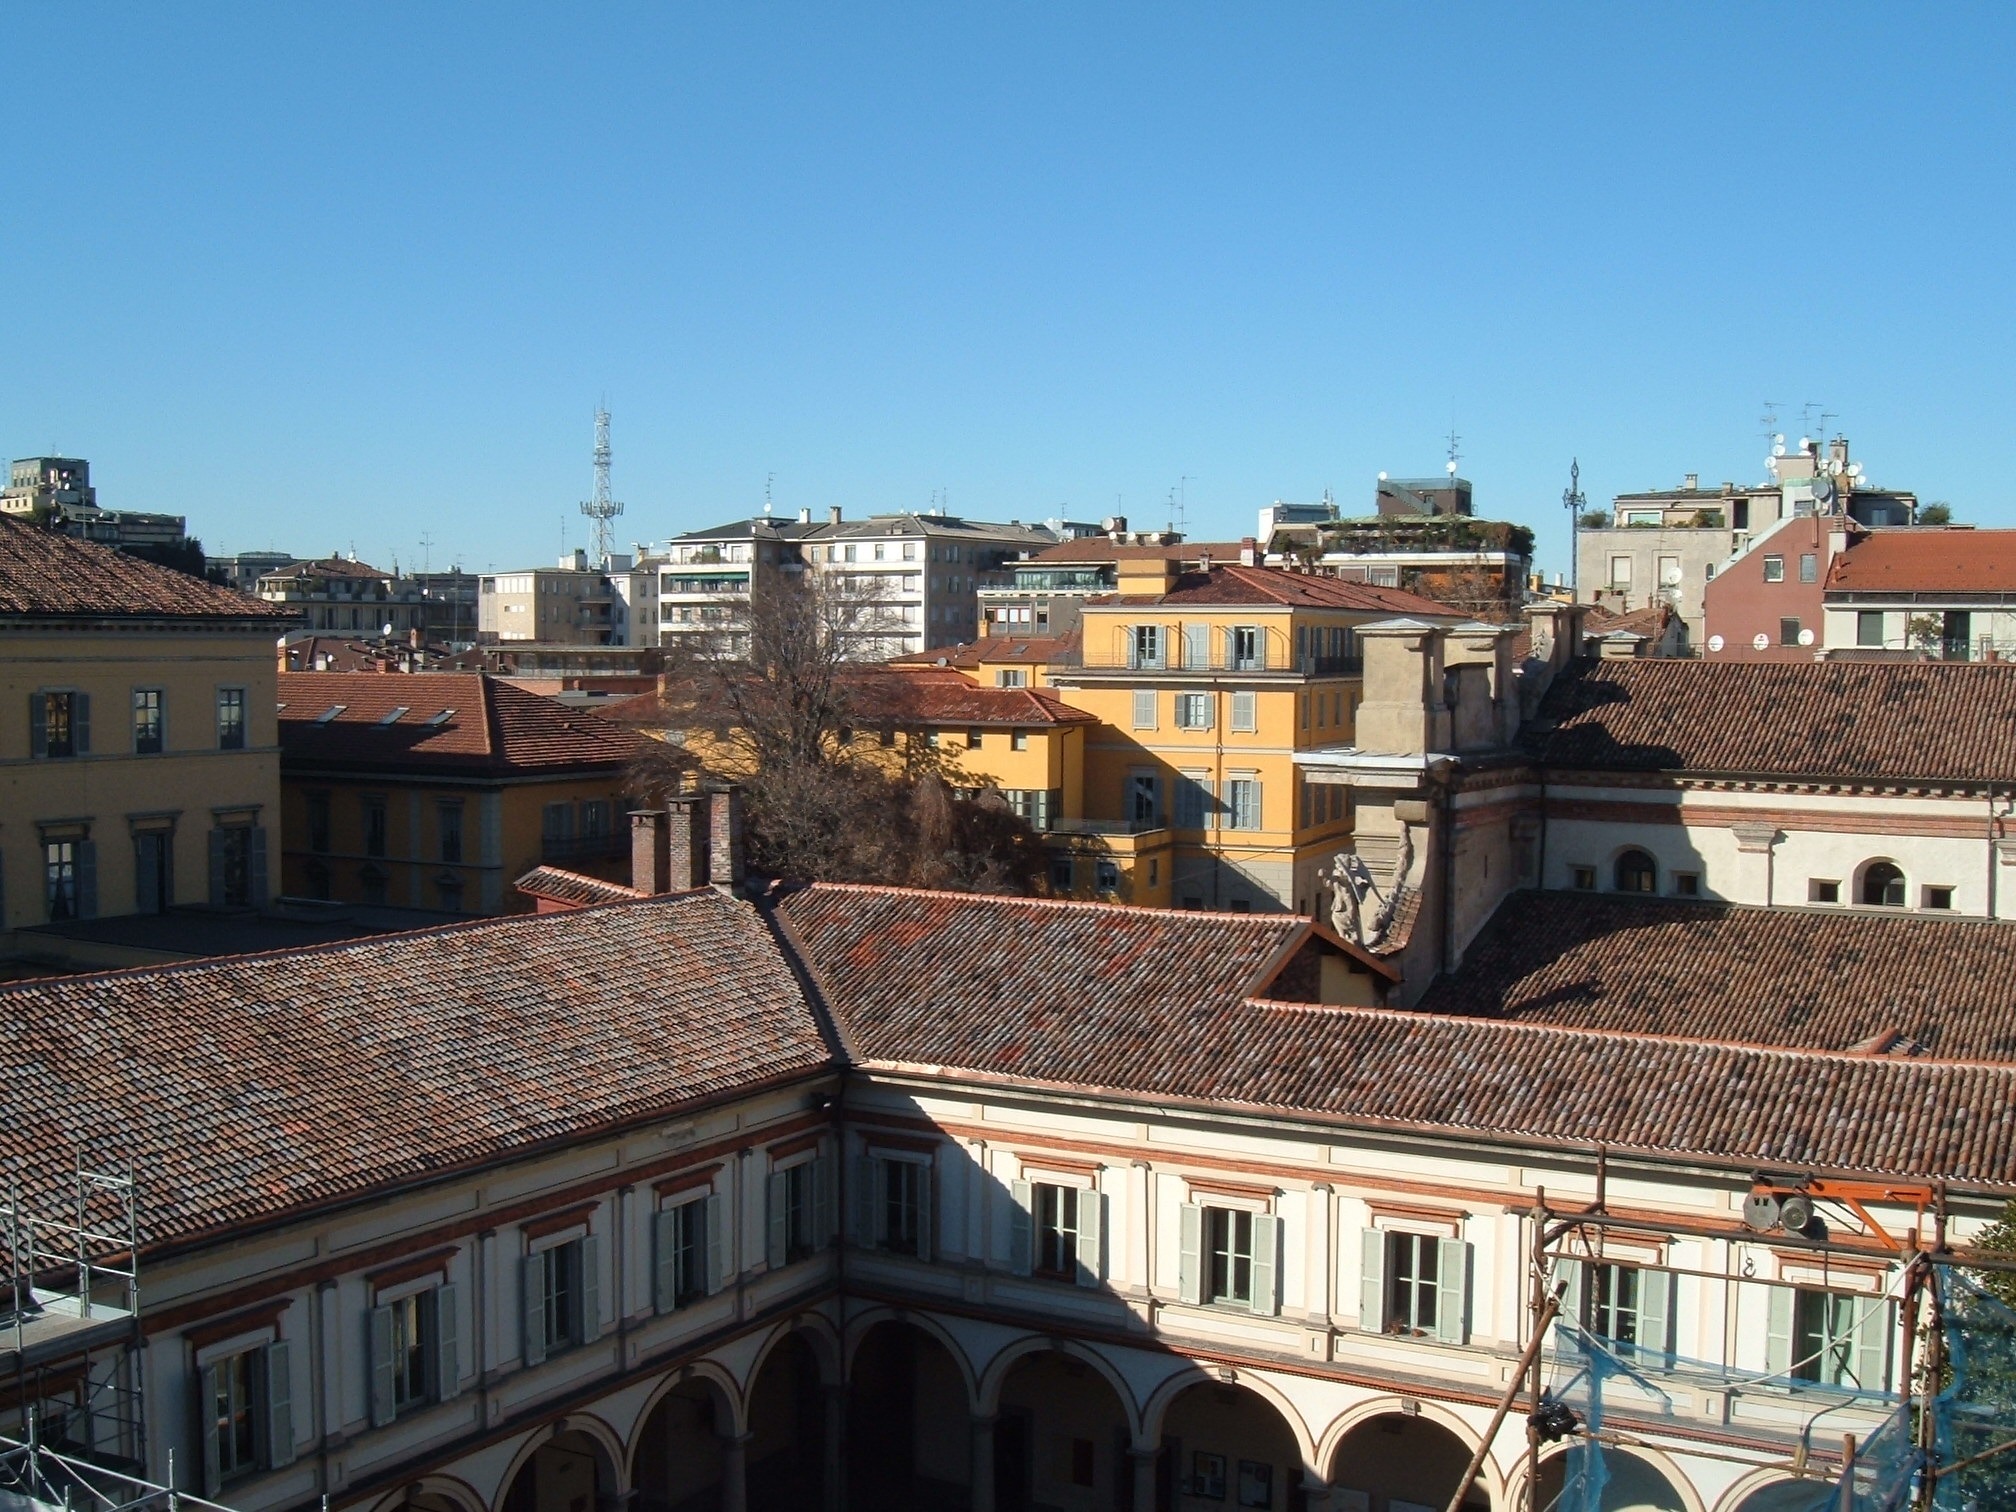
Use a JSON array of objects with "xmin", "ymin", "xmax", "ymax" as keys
[{"xmin": 633, "ymin": 573, "xmax": 1042, "ymax": 893}]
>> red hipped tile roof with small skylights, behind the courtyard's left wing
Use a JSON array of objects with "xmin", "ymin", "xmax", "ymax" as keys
[{"xmin": 280, "ymin": 671, "xmax": 643, "ymax": 772}]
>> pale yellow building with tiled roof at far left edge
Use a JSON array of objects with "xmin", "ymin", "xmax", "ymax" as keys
[{"xmin": 0, "ymin": 518, "xmax": 290, "ymax": 960}]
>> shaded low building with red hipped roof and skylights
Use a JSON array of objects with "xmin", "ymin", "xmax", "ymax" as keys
[{"xmin": 278, "ymin": 671, "xmax": 639, "ymax": 913}]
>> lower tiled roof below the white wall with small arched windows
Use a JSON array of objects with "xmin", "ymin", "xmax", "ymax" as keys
[{"xmin": 1421, "ymin": 893, "xmax": 2016, "ymax": 1060}]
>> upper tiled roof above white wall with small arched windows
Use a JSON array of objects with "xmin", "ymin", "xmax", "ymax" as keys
[{"xmin": 1530, "ymin": 657, "xmax": 2016, "ymax": 782}]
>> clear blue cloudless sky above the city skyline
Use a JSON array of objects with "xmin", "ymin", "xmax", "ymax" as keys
[{"xmin": 0, "ymin": 0, "xmax": 2016, "ymax": 569}]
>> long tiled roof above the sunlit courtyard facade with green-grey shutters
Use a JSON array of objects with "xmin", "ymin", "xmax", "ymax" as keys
[{"xmin": 784, "ymin": 885, "xmax": 2016, "ymax": 1185}]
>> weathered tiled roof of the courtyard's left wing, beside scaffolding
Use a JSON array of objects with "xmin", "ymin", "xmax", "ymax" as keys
[{"xmin": 0, "ymin": 889, "xmax": 829, "ymax": 1242}]
